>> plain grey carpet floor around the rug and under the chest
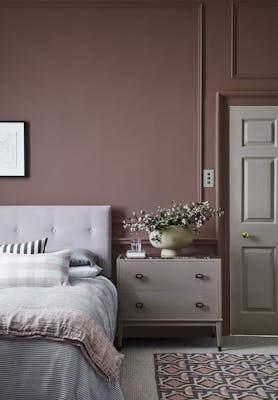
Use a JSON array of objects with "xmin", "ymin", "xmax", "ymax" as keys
[{"xmin": 121, "ymin": 336, "xmax": 278, "ymax": 400}]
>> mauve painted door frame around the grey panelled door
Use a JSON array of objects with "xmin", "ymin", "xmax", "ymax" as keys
[{"xmin": 215, "ymin": 90, "xmax": 278, "ymax": 335}]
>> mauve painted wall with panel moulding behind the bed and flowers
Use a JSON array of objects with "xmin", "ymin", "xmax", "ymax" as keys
[{"xmin": 0, "ymin": 0, "xmax": 278, "ymax": 328}]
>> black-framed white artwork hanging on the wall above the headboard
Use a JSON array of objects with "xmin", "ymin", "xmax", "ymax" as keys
[{"xmin": 0, "ymin": 121, "xmax": 25, "ymax": 176}]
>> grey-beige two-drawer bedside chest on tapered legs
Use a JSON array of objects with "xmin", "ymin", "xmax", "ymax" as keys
[{"xmin": 117, "ymin": 256, "xmax": 222, "ymax": 349}]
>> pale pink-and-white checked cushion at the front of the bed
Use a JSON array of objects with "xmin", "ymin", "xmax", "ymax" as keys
[{"xmin": 0, "ymin": 251, "xmax": 70, "ymax": 288}]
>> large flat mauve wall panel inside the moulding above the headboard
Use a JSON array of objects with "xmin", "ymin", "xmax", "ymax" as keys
[{"xmin": 0, "ymin": 2, "xmax": 198, "ymax": 210}]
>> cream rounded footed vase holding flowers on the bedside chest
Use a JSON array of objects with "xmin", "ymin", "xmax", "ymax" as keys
[{"xmin": 149, "ymin": 225, "xmax": 193, "ymax": 258}]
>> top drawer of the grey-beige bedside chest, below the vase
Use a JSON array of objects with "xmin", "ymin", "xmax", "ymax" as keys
[{"xmin": 117, "ymin": 259, "xmax": 221, "ymax": 291}]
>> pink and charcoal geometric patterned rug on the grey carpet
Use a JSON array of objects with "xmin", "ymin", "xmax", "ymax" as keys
[{"xmin": 154, "ymin": 353, "xmax": 278, "ymax": 400}]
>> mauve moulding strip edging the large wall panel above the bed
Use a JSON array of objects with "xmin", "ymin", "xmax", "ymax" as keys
[{"xmin": 0, "ymin": 0, "xmax": 204, "ymax": 201}]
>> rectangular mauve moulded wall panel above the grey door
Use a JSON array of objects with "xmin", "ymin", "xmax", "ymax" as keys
[{"xmin": 231, "ymin": 0, "xmax": 278, "ymax": 79}]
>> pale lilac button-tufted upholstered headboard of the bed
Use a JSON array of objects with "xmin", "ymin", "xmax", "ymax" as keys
[{"xmin": 0, "ymin": 206, "xmax": 111, "ymax": 278}]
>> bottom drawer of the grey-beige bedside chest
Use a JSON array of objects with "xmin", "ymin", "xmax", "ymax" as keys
[{"xmin": 119, "ymin": 290, "xmax": 221, "ymax": 320}]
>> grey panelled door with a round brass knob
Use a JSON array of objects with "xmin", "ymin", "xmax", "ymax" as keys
[{"xmin": 230, "ymin": 107, "xmax": 278, "ymax": 334}]
